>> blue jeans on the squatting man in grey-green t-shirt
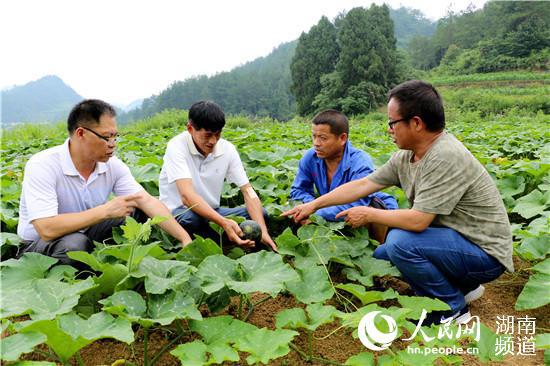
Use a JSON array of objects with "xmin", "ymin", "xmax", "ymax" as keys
[{"xmin": 373, "ymin": 227, "xmax": 504, "ymax": 313}]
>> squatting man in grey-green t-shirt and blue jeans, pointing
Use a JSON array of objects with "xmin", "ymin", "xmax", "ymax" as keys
[{"xmin": 283, "ymin": 80, "xmax": 514, "ymax": 324}]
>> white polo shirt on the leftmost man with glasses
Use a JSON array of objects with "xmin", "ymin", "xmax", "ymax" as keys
[{"xmin": 17, "ymin": 139, "xmax": 143, "ymax": 240}]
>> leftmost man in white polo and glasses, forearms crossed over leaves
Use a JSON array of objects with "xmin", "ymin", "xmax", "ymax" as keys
[{"xmin": 17, "ymin": 99, "xmax": 191, "ymax": 268}]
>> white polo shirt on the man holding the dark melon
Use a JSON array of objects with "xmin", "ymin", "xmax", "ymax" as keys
[{"xmin": 159, "ymin": 131, "xmax": 248, "ymax": 210}]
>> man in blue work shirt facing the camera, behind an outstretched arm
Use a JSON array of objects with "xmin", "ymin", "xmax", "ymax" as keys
[{"xmin": 290, "ymin": 109, "xmax": 397, "ymax": 242}]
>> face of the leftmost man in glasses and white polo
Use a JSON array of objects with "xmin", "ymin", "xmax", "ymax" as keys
[{"xmin": 78, "ymin": 114, "xmax": 118, "ymax": 162}]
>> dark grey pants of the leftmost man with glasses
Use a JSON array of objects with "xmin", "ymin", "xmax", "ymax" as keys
[{"xmin": 17, "ymin": 210, "xmax": 147, "ymax": 270}]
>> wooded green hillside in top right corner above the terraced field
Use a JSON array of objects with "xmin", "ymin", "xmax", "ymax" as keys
[{"xmin": 408, "ymin": 1, "xmax": 550, "ymax": 75}]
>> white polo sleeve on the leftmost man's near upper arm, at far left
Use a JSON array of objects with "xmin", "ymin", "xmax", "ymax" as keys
[{"xmin": 21, "ymin": 161, "xmax": 59, "ymax": 222}]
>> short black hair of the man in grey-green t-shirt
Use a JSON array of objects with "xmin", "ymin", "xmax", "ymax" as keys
[{"xmin": 388, "ymin": 80, "xmax": 445, "ymax": 132}]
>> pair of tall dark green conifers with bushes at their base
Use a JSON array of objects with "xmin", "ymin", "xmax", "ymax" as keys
[{"xmin": 290, "ymin": 4, "xmax": 402, "ymax": 115}]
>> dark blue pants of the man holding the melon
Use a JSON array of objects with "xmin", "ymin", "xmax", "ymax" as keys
[{"xmin": 172, "ymin": 206, "xmax": 268, "ymax": 239}]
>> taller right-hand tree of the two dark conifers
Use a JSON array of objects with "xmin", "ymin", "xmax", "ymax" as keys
[{"xmin": 314, "ymin": 5, "xmax": 399, "ymax": 114}]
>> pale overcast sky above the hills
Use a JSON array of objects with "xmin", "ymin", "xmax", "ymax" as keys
[{"xmin": 0, "ymin": 0, "xmax": 485, "ymax": 105}]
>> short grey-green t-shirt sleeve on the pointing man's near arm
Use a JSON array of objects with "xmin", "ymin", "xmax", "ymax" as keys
[{"xmin": 412, "ymin": 159, "xmax": 473, "ymax": 215}]
